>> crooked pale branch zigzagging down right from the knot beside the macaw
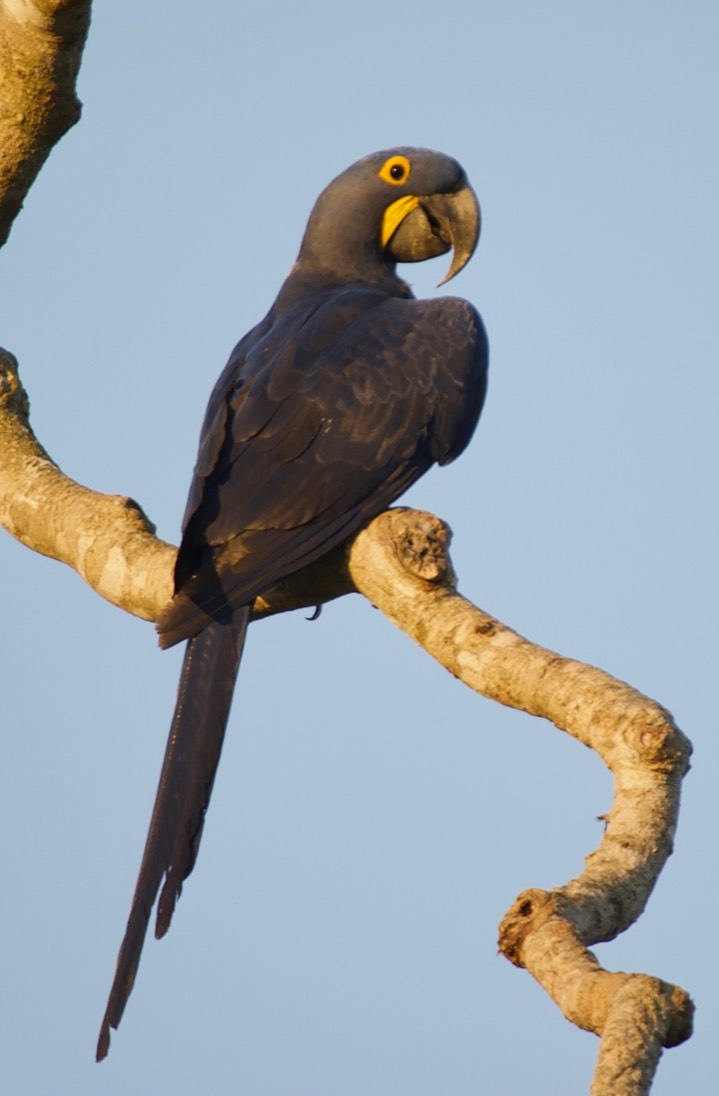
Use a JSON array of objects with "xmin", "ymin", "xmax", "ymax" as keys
[{"xmin": 350, "ymin": 511, "xmax": 694, "ymax": 1096}]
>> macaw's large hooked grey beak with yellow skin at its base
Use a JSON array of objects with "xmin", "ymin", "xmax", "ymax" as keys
[{"xmin": 387, "ymin": 183, "xmax": 481, "ymax": 285}]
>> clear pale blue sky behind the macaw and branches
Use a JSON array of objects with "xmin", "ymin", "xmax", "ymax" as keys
[{"xmin": 0, "ymin": 0, "xmax": 719, "ymax": 1096}]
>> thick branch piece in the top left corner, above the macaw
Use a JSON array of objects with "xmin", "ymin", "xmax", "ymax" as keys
[{"xmin": 0, "ymin": 0, "xmax": 90, "ymax": 246}]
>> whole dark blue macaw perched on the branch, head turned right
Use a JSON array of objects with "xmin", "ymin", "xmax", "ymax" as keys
[{"xmin": 98, "ymin": 149, "xmax": 488, "ymax": 1059}]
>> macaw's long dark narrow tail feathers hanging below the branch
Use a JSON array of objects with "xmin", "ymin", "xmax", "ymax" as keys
[{"xmin": 96, "ymin": 608, "xmax": 250, "ymax": 1062}]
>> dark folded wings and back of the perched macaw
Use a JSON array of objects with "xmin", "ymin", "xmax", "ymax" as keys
[{"xmin": 160, "ymin": 289, "xmax": 487, "ymax": 646}]
